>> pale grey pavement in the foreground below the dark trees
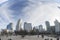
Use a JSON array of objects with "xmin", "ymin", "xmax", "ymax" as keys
[{"xmin": 0, "ymin": 35, "xmax": 60, "ymax": 40}]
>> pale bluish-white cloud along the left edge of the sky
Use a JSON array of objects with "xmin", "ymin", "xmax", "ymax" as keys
[{"xmin": 0, "ymin": 3, "xmax": 12, "ymax": 30}]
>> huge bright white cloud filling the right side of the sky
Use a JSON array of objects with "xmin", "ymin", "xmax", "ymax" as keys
[{"xmin": 25, "ymin": 2, "xmax": 60, "ymax": 27}]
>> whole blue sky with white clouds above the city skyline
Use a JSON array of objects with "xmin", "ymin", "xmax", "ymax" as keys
[{"xmin": 0, "ymin": 0, "xmax": 60, "ymax": 29}]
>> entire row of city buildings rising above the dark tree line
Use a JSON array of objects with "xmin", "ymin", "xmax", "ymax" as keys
[{"xmin": 2, "ymin": 19, "xmax": 60, "ymax": 33}]
